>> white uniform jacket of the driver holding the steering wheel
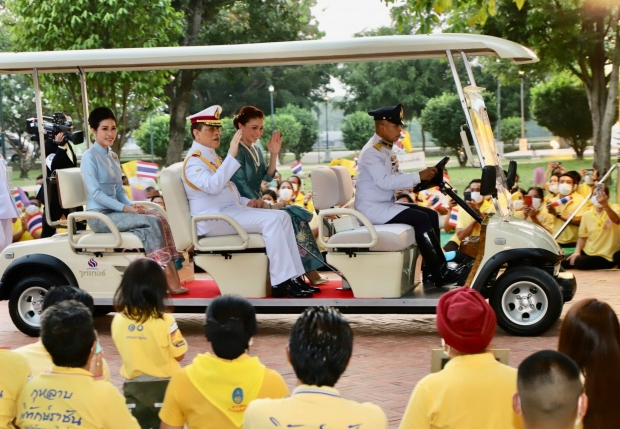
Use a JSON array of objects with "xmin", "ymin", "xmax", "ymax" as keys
[{"xmin": 355, "ymin": 134, "xmax": 420, "ymax": 225}]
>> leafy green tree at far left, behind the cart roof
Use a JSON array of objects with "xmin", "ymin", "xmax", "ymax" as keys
[{"xmin": 2, "ymin": 0, "xmax": 182, "ymax": 154}]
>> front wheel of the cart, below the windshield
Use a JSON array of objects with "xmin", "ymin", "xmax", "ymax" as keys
[{"xmin": 489, "ymin": 267, "xmax": 564, "ymax": 336}]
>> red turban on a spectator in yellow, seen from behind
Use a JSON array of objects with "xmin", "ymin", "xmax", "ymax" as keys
[{"xmin": 437, "ymin": 286, "xmax": 497, "ymax": 353}]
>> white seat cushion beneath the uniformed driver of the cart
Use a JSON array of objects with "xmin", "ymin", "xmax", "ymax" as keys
[{"xmin": 327, "ymin": 224, "xmax": 415, "ymax": 252}]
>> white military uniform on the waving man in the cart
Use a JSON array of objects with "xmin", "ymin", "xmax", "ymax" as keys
[{"xmin": 183, "ymin": 142, "xmax": 305, "ymax": 285}]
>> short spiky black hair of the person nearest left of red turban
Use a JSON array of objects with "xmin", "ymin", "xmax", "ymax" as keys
[{"xmin": 288, "ymin": 306, "xmax": 353, "ymax": 387}]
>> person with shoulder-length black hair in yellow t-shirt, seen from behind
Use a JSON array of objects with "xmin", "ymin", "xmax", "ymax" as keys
[{"xmin": 111, "ymin": 258, "xmax": 187, "ymax": 429}]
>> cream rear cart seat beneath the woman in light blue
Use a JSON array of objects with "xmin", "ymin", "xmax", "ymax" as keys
[{"xmin": 56, "ymin": 168, "xmax": 166, "ymax": 252}]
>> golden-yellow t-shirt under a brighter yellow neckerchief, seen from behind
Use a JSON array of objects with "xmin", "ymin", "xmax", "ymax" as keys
[{"xmin": 159, "ymin": 354, "xmax": 289, "ymax": 429}]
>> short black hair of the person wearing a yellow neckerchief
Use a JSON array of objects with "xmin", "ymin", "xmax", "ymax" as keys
[{"xmin": 205, "ymin": 295, "xmax": 258, "ymax": 360}]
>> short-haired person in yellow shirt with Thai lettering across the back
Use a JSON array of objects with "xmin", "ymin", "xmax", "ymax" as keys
[{"xmin": 16, "ymin": 301, "xmax": 140, "ymax": 429}]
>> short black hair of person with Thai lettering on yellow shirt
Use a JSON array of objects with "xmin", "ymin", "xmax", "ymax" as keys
[{"xmin": 41, "ymin": 300, "xmax": 97, "ymax": 368}]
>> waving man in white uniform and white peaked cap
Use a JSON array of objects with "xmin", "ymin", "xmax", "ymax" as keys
[{"xmin": 183, "ymin": 106, "xmax": 312, "ymax": 298}]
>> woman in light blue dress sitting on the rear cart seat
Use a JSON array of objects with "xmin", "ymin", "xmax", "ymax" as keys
[{"xmin": 80, "ymin": 107, "xmax": 189, "ymax": 294}]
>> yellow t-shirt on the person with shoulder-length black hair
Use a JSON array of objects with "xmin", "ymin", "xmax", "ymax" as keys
[{"xmin": 111, "ymin": 313, "xmax": 187, "ymax": 380}]
